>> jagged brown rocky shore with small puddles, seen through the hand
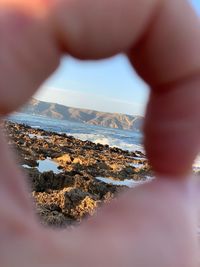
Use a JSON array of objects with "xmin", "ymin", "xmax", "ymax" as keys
[{"xmin": 4, "ymin": 121, "xmax": 152, "ymax": 227}]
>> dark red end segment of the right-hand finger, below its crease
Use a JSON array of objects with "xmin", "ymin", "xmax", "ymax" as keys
[{"xmin": 144, "ymin": 76, "xmax": 200, "ymax": 177}]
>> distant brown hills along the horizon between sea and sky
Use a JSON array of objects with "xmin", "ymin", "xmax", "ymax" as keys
[{"xmin": 20, "ymin": 98, "xmax": 144, "ymax": 132}]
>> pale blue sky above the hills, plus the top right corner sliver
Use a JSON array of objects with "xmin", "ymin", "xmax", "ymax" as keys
[{"xmin": 35, "ymin": 0, "xmax": 200, "ymax": 115}]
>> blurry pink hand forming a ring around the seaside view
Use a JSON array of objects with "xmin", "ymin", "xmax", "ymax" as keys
[{"xmin": 0, "ymin": 0, "xmax": 200, "ymax": 267}]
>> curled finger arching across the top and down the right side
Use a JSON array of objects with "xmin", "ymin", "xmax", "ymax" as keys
[{"xmin": 51, "ymin": 0, "xmax": 200, "ymax": 177}]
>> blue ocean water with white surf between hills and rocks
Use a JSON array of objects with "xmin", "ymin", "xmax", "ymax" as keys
[{"xmin": 8, "ymin": 113, "xmax": 144, "ymax": 152}]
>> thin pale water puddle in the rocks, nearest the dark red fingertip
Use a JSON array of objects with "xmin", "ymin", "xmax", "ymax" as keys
[{"xmin": 96, "ymin": 177, "xmax": 153, "ymax": 188}]
